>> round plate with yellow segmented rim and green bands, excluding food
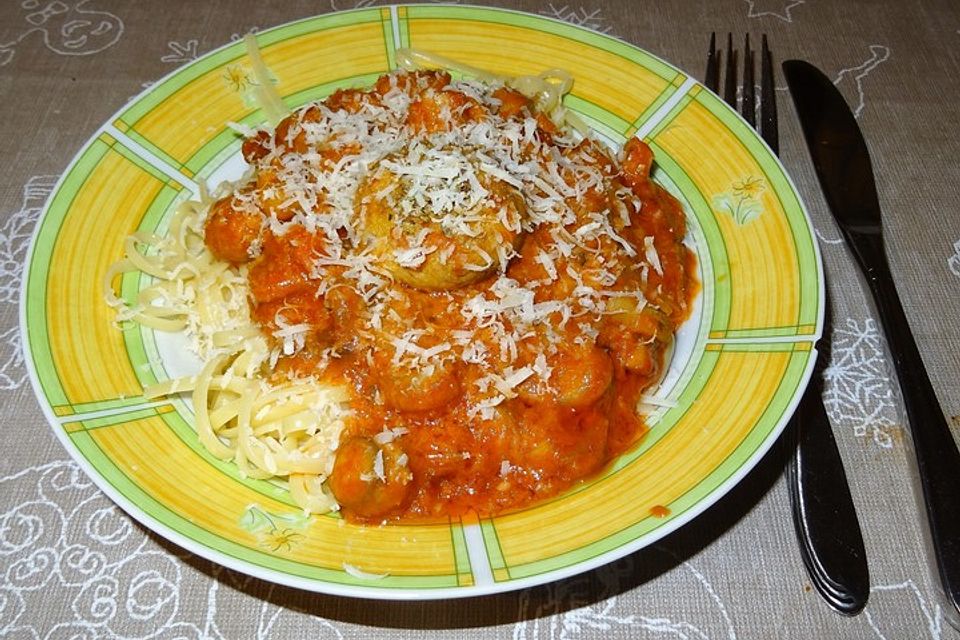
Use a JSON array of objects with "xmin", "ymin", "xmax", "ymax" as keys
[{"xmin": 21, "ymin": 5, "xmax": 824, "ymax": 599}]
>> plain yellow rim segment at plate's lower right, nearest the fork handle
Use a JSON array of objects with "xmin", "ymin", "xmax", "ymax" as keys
[{"xmin": 494, "ymin": 352, "xmax": 791, "ymax": 567}]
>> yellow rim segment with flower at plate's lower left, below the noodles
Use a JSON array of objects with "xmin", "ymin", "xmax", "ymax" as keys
[{"xmin": 89, "ymin": 417, "xmax": 456, "ymax": 576}]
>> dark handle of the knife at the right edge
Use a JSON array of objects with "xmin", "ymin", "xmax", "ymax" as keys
[{"xmin": 844, "ymin": 230, "xmax": 960, "ymax": 612}]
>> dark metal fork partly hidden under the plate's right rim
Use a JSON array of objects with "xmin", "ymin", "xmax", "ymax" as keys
[{"xmin": 704, "ymin": 33, "xmax": 870, "ymax": 616}]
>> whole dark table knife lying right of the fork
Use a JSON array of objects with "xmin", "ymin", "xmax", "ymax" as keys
[{"xmin": 783, "ymin": 60, "xmax": 960, "ymax": 616}]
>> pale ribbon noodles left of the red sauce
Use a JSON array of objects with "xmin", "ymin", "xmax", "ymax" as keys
[{"xmin": 104, "ymin": 199, "xmax": 347, "ymax": 513}]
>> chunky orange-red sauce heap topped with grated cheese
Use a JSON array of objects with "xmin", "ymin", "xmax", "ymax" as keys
[{"xmin": 204, "ymin": 71, "xmax": 697, "ymax": 522}]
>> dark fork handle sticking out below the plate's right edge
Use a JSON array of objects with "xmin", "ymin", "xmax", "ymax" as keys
[{"xmin": 788, "ymin": 376, "xmax": 870, "ymax": 616}]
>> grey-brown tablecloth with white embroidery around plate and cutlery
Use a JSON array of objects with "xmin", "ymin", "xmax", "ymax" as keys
[{"xmin": 0, "ymin": 0, "xmax": 960, "ymax": 639}]
